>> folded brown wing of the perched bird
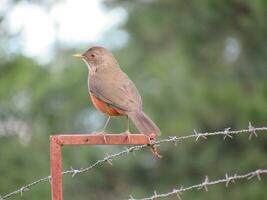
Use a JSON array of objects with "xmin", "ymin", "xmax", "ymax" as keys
[{"xmin": 89, "ymin": 68, "xmax": 142, "ymax": 112}]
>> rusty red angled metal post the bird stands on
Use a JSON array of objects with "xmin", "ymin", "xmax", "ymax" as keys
[{"xmin": 50, "ymin": 134, "xmax": 152, "ymax": 200}]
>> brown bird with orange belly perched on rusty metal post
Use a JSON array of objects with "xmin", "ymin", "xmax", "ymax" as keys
[{"xmin": 73, "ymin": 46, "xmax": 160, "ymax": 141}]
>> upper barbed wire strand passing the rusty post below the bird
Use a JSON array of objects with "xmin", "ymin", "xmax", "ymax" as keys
[{"xmin": 0, "ymin": 122, "xmax": 267, "ymax": 200}]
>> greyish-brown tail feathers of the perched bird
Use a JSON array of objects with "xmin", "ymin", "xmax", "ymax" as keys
[{"xmin": 127, "ymin": 111, "xmax": 160, "ymax": 135}]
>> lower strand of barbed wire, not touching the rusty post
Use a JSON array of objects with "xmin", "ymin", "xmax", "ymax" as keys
[{"xmin": 129, "ymin": 169, "xmax": 267, "ymax": 200}]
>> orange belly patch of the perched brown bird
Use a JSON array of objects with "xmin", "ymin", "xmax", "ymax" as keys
[{"xmin": 90, "ymin": 93, "xmax": 126, "ymax": 116}]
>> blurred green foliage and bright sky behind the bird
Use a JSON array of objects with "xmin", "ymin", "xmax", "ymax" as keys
[{"xmin": 0, "ymin": 0, "xmax": 267, "ymax": 200}]
